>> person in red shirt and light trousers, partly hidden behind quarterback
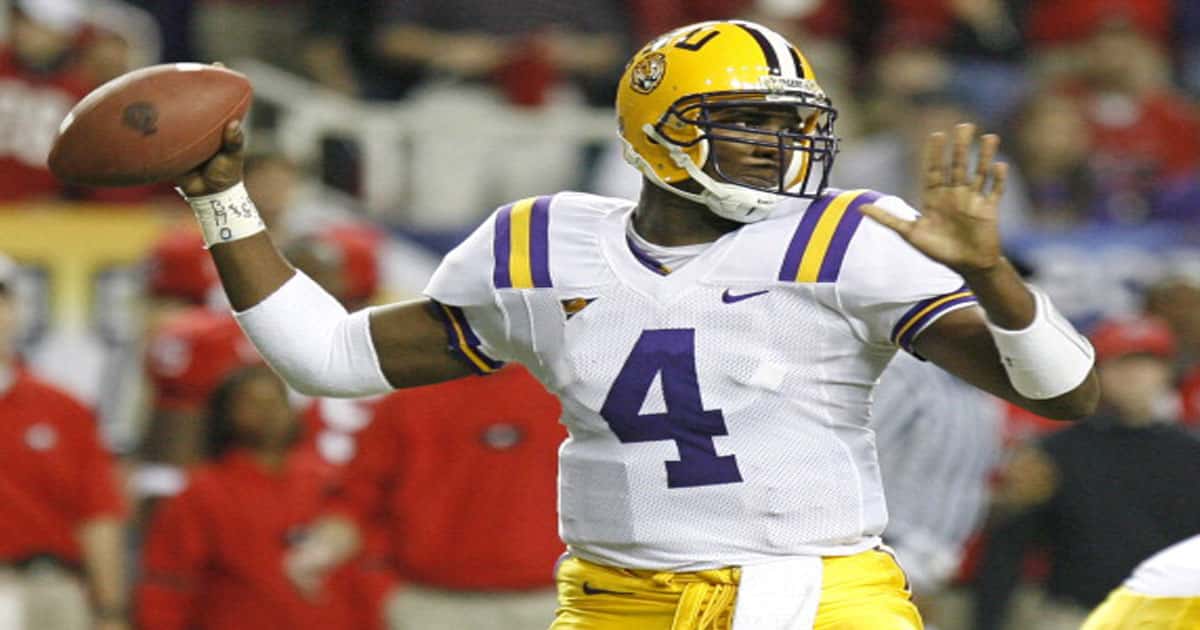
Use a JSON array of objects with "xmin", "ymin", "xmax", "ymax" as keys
[{"xmin": 282, "ymin": 366, "xmax": 566, "ymax": 630}]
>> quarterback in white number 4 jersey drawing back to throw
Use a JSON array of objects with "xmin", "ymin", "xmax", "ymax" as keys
[{"xmin": 169, "ymin": 22, "xmax": 1098, "ymax": 630}]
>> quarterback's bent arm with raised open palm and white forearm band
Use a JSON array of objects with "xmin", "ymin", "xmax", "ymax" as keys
[{"xmin": 862, "ymin": 124, "xmax": 1099, "ymax": 419}]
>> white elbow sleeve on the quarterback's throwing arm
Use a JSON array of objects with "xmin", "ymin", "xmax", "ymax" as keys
[{"xmin": 235, "ymin": 271, "xmax": 392, "ymax": 398}]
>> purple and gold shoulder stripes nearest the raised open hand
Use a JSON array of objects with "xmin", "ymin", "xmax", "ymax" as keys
[{"xmin": 779, "ymin": 190, "xmax": 882, "ymax": 282}]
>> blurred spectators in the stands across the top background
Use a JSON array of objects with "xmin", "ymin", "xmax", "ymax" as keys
[{"xmin": 7, "ymin": 0, "xmax": 1200, "ymax": 230}]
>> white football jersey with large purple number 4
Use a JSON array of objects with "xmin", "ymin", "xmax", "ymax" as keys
[{"xmin": 425, "ymin": 191, "xmax": 974, "ymax": 571}]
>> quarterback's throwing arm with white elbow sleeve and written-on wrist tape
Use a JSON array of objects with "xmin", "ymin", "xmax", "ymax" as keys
[{"xmin": 176, "ymin": 122, "xmax": 473, "ymax": 396}]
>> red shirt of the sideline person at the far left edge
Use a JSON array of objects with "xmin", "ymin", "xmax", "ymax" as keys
[{"xmin": 0, "ymin": 370, "xmax": 124, "ymax": 563}]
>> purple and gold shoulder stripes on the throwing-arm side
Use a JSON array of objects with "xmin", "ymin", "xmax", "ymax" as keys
[{"xmin": 492, "ymin": 196, "xmax": 553, "ymax": 289}]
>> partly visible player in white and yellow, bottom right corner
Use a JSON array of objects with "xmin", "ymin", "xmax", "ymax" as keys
[{"xmin": 1080, "ymin": 535, "xmax": 1200, "ymax": 630}]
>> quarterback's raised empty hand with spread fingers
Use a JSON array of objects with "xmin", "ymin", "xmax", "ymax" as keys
[{"xmin": 862, "ymin": 124, "xmax": 1008, "ymax": 275}]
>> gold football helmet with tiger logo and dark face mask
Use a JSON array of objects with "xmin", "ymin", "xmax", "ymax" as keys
[{"xmin": 617, "ymin": 20, "xmax": 838, "ymax": 222}]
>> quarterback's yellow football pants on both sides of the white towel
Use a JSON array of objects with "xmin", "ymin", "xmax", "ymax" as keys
[{"xmin": 551, "ymin": 551, "xmax": 923, "ymax": 630}]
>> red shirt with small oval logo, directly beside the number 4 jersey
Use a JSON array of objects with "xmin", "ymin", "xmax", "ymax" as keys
[{"xmin": 336, "ymin": 366, "xmax": 566, "ymax": 590}]
